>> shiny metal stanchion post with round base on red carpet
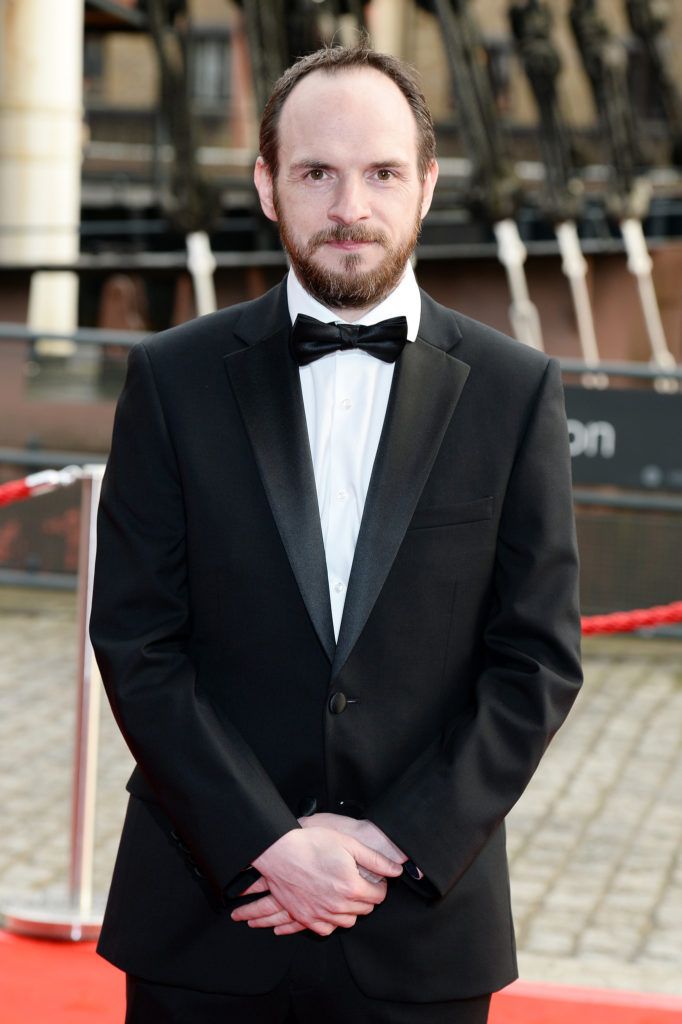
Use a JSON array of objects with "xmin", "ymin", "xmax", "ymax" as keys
[{"xmin": 1, "ymin": 465, "xmax": 104, "ymax": 942}]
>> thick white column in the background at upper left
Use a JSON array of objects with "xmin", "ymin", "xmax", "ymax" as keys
[{"xmin": 0, "ymin": 0, "xmax": 83, "ymax": 354}]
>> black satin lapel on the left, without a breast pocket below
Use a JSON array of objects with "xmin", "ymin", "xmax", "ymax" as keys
[{"xmin": 224, "ymin": 328, "xmax": 336, "ymax": 662}]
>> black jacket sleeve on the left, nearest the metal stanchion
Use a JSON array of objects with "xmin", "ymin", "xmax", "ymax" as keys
[{"xmin": 90, "ymin": 345, "xmax": 298, "ymax": 891}]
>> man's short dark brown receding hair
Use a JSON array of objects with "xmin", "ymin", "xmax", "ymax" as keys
[{"xmin": 259, "ymin": 43, "xmax": 435, "ymax": 180}]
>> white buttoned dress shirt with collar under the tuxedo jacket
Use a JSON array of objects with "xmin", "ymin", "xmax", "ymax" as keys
[{"xmin": 287, "ymin": 264, "xmax": 421, "ymax": 640}]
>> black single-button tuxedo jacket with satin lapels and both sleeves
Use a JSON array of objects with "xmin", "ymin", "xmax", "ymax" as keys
[{"xmin": 91, "ymin": 286, "xmax": 581, "ymax": 1000}]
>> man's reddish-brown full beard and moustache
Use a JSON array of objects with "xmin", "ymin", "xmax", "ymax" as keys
[{"xmin": 274, "ymin": 197, "xmax": 422, "ymax": 309}]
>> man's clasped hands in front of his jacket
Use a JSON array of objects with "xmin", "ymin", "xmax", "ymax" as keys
[{"xmin": 231, "ymin": 814, "xmax": 408, "ymax": 935}]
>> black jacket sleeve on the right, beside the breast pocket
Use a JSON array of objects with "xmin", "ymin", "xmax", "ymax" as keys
[{"xmin": 367, "ymin": 361, "xmax": 582, "ymax": 896}]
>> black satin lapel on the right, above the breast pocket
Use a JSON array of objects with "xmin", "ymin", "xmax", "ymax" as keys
[{"xmin": 332, "ymin": 339, "xmax": 469, "ymax": 676}]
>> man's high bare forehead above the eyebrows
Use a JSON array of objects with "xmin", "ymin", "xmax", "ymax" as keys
[{"xmin": 279, "ymin": 68, "xmax": 417, "ymax": 162}]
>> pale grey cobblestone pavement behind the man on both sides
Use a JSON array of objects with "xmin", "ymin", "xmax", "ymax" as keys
[{"xmin": 0, "ymin": 588, "xmax": 682, "ymax": 993}]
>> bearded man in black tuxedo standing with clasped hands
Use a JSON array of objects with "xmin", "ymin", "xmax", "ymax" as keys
[{"xmin": 91, "ymin": 41, "xmax": 581, "ymax": 1024}]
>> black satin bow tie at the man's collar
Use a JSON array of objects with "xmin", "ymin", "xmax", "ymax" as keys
[{"xmin": 289, "ymin": 313, "xmax": 408, "ymax": 367}]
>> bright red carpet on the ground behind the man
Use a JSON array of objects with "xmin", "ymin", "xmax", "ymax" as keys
[{"xmin": 0, "ymin": 932, "xmax": 682, "ymax": 1024}]
